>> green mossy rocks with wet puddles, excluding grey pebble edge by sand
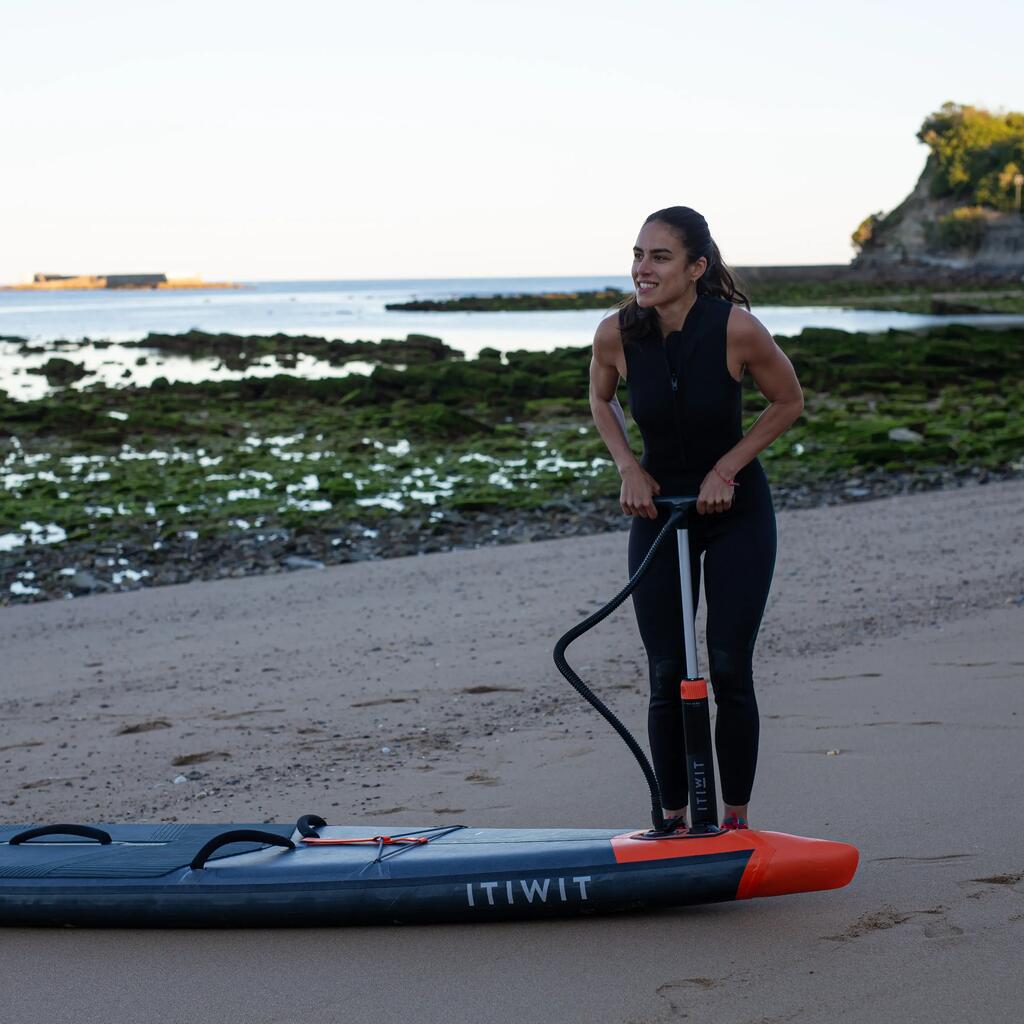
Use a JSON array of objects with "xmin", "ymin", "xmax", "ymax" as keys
[{"xmin": 0, "ymin": 326, "xmax": 1024, "ymax": 561}]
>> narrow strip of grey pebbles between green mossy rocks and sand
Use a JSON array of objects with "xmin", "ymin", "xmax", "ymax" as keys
[{"xmin": 0, "ymin": 467, "xmax": 1024, "ymax": 605}]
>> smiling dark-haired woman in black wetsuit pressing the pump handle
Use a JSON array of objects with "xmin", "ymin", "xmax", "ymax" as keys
[{"xmin": 590, "ymin": 206, "xmax": 804, "ymax": 828}]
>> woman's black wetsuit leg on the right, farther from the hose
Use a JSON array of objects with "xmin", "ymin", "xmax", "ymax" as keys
[{"xmin": 703, "ymin": 480, "xmax": 776, "ymax": 806}]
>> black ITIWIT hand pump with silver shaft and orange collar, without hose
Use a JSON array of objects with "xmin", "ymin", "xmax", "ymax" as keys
[{"xmin": 654, "ymin": 495, "xmax": 721, "ymax": 837}]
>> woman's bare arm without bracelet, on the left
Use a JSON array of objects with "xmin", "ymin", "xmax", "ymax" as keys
[{"xmin": 590, "ymin": 316, "xmax": 660, "ymax": 519}]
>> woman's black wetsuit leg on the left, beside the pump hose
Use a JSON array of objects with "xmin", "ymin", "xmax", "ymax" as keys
[{"xmin": 629, "ymin": 514, "xmax": 700, "ymax": 810}]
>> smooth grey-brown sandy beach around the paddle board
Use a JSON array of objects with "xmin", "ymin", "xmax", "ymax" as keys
[{"xmin": 0, "ymin": 480, "xmax": 1024, "ymax": 1024}]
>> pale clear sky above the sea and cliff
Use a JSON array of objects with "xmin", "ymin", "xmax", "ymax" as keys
[{"xmin": 0, "ymin": 0, "xmax": 1024, "ymax": 283}]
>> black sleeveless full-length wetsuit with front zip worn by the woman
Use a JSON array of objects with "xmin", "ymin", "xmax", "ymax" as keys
[{"xmin": 624, "ymin": 296, "xmax": 775, "ymax": 810}]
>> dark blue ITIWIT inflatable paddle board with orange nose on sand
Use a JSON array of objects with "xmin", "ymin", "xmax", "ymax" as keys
[{"xmin": 0, "ymin": 815, "xmax": 857, "ymax": 928}]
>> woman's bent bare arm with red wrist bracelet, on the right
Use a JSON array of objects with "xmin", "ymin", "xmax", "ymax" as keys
[{"xmin": 697, "ymin": 306, "xmax": 804, "ymax": 513}]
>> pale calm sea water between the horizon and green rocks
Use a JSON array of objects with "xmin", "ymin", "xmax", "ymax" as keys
[{"xmin": 0, "ymin": 274, "xmax": 1024, "ymax": 400}]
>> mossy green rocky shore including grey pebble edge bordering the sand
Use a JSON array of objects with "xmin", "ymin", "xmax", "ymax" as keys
[{"xmin": 0, "ymin": 325, "xmax": 1024, "ymax": 604}]
